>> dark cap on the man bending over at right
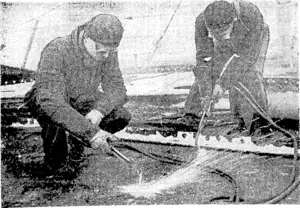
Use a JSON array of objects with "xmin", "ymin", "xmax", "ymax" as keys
[{"xmin": 204, "ymin": 1, "xmax": 235, "ymax": 29}]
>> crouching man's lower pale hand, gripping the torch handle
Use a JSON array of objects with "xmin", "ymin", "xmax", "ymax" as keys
[{"xmin": 90, "ymin": 129, "xmax": 117, "ymax": 155}]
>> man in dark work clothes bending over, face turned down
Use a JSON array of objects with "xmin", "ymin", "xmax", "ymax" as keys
[{"xmin": 185, "ymin": 0, "xmax": 269, "ymax": 135}]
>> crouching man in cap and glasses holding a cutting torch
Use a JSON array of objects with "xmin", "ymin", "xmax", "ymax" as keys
[{"xmin": 25, "ymin": 14, "xmax": 131, "ymax": 178}]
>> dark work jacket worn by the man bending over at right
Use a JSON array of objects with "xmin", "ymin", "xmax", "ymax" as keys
[{"xmin": 194, "ymin": 1, "xmax": 264, "ymax": 92}]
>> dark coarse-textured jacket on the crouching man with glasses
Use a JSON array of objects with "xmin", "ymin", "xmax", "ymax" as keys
[{"xmin": 25, "ymin": 27, "xmax": 128, "ymax": 141}]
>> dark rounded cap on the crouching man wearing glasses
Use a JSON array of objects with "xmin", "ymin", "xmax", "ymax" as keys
[{"xmin": 84, "ymin": 14, "xmax": 124, "ymax": 47}]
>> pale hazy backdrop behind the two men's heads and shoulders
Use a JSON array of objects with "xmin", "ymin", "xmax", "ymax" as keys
[{"xmin": 0, "ymin": 0, "xmax": 299, "ymax": 75}]
